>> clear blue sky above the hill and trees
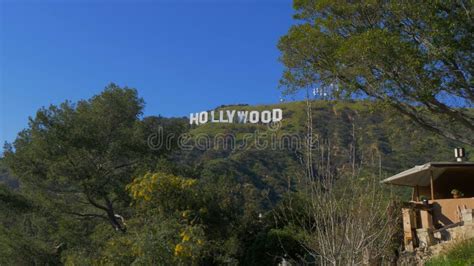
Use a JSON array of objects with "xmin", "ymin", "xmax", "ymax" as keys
[{"xmin": 0, "ymin": 0, "xmax": 294, "ymax": 144}]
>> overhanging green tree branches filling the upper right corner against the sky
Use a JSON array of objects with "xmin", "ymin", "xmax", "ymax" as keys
[{"xmin": 278, "ymin": 0, "xmax": 474, "ymax": 146}]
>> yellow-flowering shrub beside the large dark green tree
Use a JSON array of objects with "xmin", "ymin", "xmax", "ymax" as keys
[{"xmin": 127, "ymin": 172, "xmax": 207, "ymax": 265}]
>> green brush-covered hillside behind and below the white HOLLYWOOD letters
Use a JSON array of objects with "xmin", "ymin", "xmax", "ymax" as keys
[{"xmin": 177, "ymin": 101, "xmax": 473, "ymax": 201}]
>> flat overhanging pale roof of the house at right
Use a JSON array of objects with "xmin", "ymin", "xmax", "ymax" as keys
[{"xmin": 382, "ymin": 162, "xmax": 474, "ymax": 187}]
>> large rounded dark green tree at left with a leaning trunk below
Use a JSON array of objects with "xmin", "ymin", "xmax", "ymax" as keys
[{"xmin": 5, "ymin": 84, "xmax": 147, "ymax": 231}]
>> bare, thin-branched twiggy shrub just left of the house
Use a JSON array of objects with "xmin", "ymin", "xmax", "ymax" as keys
[{"xmin": 275, "ymin": 99, "xmax": 398, "ymax": 265}]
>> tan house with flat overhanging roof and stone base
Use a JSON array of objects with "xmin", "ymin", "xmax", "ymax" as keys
[{"xmin": 382, "ymin": 158, "xmax": 474, "ymax": 251}]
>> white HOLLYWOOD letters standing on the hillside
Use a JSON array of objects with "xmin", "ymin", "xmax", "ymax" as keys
[{"xmin": 189, "ymin": 109, "xmax": 283, "ymax": 125}]
